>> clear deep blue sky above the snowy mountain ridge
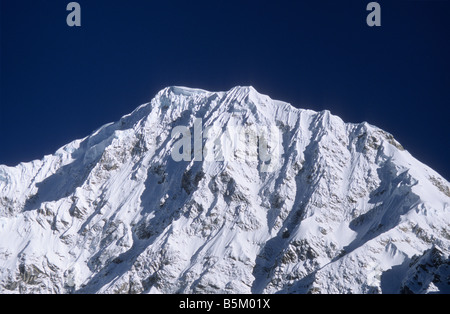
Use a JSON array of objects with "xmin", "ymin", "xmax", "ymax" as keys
[{"xmin": 0, "ymin": 0, "xmax": 450, "ymax": 179}]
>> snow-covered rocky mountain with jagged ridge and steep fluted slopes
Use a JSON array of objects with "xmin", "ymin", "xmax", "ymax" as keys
[{"xmin": 0, "ymin": 87, "xmax": 450, "ymax": 293}]
